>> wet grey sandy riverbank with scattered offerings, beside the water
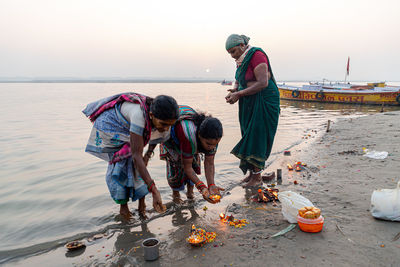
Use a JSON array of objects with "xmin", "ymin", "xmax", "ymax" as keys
[{"xmin": 6, "ymin": 112, "xmax": 400, "ymax": 266}]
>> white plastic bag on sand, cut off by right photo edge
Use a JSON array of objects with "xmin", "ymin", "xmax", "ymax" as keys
[{"xmin": 371, "ymin": 181, "xmax": 400, "ymax": 221}]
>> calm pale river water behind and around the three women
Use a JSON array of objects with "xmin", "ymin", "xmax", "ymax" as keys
[{"xmin": 0, "ymin": 83, "xmax": 399, "ymax": 263}]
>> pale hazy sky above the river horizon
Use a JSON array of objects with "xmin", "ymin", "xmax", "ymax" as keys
[{"xmin": 0, "ymin": 0, "xmax": 400, "ymax": 81}]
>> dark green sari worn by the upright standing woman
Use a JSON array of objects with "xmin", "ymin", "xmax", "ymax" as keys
[{"xmin": 231, "ymin": 47, "xmax": 280, "ymax": 174}]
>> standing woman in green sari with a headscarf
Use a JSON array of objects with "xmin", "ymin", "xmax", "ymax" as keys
[{"xmin": 225, "ymin": 34, "xmax": 280, "ymax": 187}]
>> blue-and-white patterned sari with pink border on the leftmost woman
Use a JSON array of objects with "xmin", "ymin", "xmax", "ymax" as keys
[{"xmin": 83, "ymin": 93, "xmax": 151, "ymax": 204}]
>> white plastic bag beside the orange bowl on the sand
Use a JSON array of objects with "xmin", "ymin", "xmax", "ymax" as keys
[{"xmin": 278, "ymin": 191, "xmax": 314, "ymax": 223}]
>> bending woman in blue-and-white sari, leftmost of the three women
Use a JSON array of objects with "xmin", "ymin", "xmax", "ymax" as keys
[{"xmin": 83, "ymin": 93, "xmax": 179, "ymax": 220}]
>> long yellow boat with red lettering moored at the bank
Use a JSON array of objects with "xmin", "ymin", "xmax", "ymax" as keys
[{"xmin": 278, "ymin": 82, "xmax": 400, "ymax": 105}]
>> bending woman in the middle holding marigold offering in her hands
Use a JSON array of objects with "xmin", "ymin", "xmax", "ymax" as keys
[{"xmin": 160, "ymin": 106, "xmax": 223, "ymax": 203}]
